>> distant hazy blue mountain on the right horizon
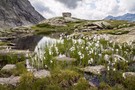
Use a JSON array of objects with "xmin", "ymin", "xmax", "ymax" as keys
[{"xmin": 105, "ymin": 13, "xmax": 135, "ymax": 21}]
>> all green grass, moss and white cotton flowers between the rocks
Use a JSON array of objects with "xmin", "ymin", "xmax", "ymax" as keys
[{"xmin": 0, "ymin": 18, "xmax": 135, "ymax": 90}]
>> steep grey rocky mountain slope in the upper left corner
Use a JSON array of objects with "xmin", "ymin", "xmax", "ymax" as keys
[{"xmin": 0, "ymin": 0, "xmax": 44, "ymax": 28}]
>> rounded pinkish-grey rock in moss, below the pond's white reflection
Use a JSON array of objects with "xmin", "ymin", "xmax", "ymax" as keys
[{"xmin": 33, "ymin": 70, "xmax": 51, "ymax": 78}]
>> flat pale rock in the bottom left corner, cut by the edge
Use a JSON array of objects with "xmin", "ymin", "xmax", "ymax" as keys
[{"xmin": 0, "ymin": 76, "xmax": 20, "ymax": 86}]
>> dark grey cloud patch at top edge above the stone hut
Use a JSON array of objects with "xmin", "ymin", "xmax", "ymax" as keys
[{"xmin": 56, "ymin": 0, "xmax": 82, "ymax": 9}]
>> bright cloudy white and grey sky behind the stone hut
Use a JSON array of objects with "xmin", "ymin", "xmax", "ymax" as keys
[{"xmin": 29, "ymin": 0, "xmax": 135, "ymax": 20}]
